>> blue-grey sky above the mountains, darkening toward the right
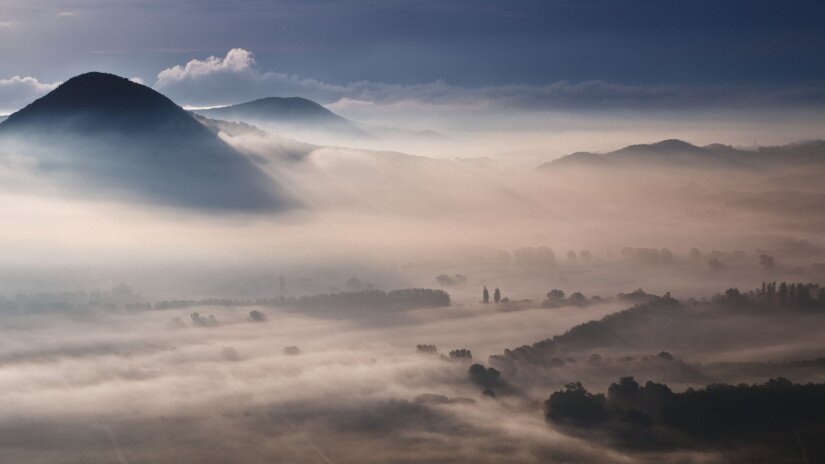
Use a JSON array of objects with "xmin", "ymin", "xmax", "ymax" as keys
[{"xmin": 0, "ymin": 0, "xmax": 825, "ymax": 114}]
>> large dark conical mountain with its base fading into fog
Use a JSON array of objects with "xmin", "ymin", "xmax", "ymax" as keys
[{"xmin": 0, "ymin": 72, "xmax": 286, "ymax": 210}]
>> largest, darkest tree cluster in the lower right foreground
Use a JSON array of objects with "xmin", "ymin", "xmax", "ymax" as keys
[{"xmin": 545, "ymin": 377, "xmax": 825, "ymax": 437}]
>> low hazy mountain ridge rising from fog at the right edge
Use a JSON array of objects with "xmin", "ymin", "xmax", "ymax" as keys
[{"xmin": 538, "ymin": 139, "xmax": 825, "ymax": 170}]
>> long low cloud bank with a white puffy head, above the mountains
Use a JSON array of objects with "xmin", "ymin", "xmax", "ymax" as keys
[{"xmin": 155, "ymin": 48, "xmax": 825, "ymax": 110}]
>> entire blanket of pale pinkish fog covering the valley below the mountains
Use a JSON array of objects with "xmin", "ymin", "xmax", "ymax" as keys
[{"xmin": 0, "ymin": 93, "xmax": 825, "ymax": 463}]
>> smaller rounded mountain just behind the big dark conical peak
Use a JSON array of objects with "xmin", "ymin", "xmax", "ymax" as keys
[{"xmin": 194, "ymin": 97, "xmax": 361, "ymax": 134}]
